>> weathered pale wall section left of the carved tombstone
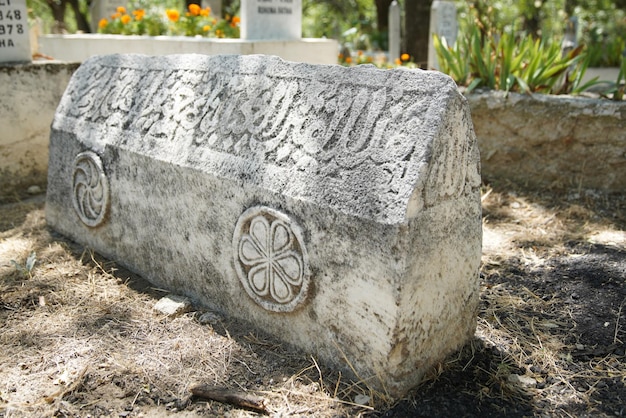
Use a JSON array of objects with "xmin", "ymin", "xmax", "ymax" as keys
[{"xmin": 0, "ymin": 62, "xmax": 78, "ymax": 201}]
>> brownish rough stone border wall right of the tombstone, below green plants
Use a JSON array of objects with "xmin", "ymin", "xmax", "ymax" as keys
[{"xmin": 468, "ymin": 92, "xmax": 626, "ymax": 192}]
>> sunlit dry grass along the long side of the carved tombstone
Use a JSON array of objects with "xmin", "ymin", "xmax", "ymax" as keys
[{"xmin": 0, "ymin": 199, "xmax": 373, "ymax": 417}]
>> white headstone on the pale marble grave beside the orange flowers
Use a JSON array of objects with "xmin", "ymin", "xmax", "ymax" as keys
[{"xmin": 241, "ymin": 0, "xmax": 302, "ymax": 41}]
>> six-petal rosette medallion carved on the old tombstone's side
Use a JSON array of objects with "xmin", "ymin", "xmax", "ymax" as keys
[{"xmin": 233, "ymin": 206, "xmax": 310, "ymax": 312}]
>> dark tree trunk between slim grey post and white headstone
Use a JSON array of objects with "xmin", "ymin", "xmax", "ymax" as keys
[{"xmin": 404, "ymin": 0, "xmax": 432, "ymax": 68}]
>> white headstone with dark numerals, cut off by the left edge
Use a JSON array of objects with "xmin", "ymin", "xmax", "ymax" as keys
[{"xmin": 0, "ymin": 0, "xmax": 32, "ymax": 62}]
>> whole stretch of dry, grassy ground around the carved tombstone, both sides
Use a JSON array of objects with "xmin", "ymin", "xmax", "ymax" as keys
[{"xmin": 0, "ymin": 184, "xmax": 626, "ymax": 418}]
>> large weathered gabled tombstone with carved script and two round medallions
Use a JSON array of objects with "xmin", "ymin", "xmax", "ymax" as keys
[{"xmin": 46, "ymin": 55, "xmax": 481, "ymax": 396}]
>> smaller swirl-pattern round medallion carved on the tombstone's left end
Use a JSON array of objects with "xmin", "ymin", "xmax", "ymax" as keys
[{"xmin": 72, "ymin": 151, "xmax": 109, "ymax": 227}]
